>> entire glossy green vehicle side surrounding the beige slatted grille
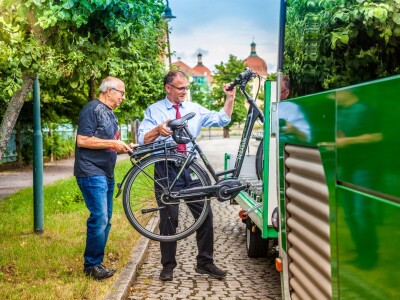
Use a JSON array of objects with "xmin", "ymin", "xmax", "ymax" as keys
[{"xmin": 278, "ymin": 76, "xmax": 400, "ymax": 299}]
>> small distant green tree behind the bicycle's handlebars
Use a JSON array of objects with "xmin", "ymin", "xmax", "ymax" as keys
[{"xmin": 211, "ymin": 55, "xmax": 250, "ymax": 138}]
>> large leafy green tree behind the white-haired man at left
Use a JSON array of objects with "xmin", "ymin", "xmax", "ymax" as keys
[{"xmin": 0, "ymin": 0, "xmax": 165, "ymax": 158}]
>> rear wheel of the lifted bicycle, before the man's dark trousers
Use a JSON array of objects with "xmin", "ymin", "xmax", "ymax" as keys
[{"xmin": 123, "ymin": 154, "xmax": 211, "ymax": 242}]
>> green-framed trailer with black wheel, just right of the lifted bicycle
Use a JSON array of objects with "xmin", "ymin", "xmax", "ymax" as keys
[{"xmin": 225, "ymin": 81, "xmax": 278, "ymax": 258}]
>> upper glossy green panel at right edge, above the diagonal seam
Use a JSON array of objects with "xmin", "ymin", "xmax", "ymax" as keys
[{"xmin": 336, "ymin": 76, "xmax": 400, "ymax": 199}]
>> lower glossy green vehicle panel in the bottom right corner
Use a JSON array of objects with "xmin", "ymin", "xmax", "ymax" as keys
[{"xmin": 337, "ymin": 186, "xmax": 400, "ymax": 299}]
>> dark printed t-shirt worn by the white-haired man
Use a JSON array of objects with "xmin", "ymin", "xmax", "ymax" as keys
[{"xmin": 74, "ymin": 99, "xmax": 119, "ymax": 178}]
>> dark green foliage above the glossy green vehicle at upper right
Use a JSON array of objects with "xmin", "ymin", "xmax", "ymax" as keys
[{"xmin": 284, "ymin": 0, "xmax": 400, "ymax": 96}]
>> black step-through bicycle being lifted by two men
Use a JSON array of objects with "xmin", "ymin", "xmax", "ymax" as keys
[{"xmin": 117, "ymin": 68, "xmax": 264, "ymax": 242}]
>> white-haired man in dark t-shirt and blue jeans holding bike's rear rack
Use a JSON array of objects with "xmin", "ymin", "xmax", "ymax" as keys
[{"xmin": 74, "ymin": 77, "xmax": 131, "ymax": 280}]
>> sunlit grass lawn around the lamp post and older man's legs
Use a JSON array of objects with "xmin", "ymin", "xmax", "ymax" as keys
[{"xmin": 0, "ymin": 160, "xmax": 139, "ymax": 300}]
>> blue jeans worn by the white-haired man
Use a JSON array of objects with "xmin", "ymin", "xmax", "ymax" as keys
[{"xmin": 76, "ymin": 175, "xmax": 114, "ymax": 268}]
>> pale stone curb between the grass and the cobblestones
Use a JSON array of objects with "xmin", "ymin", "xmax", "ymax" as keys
[{"xmin": 104, "ymin": 218, "xmax": 158, "ymax": 300}]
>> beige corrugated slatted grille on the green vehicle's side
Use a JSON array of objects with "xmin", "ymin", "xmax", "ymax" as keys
[{"xmin": 285, "ymin": 145, "xmax": 332, "ymax": 300}]
